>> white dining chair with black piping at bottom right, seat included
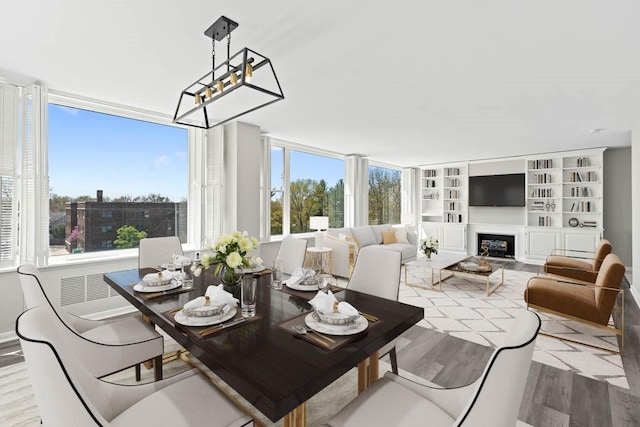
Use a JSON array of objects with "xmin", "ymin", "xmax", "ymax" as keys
[{"xmin": 326, "ymin": 310, "xmax": 540, "ymax": 427}]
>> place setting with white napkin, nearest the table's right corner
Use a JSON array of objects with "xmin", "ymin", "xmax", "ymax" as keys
[{"xmin": 278, "ymin": 290, "xmax": 381, "ymax": 351}]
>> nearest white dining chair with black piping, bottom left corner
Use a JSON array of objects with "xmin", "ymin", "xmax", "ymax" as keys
[{"xmin": 16, "ymin": 307, "xmax": 253, "ymax": 427}]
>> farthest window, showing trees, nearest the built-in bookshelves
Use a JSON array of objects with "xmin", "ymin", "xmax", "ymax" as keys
[{"xmin": 369, "ymin": 166, "xmax": 402, "ymax": 224}]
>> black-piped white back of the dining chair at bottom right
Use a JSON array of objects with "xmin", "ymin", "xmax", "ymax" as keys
[{"xmin": 455, "ymin": 310, "xmax": 541, "ymax": 427}]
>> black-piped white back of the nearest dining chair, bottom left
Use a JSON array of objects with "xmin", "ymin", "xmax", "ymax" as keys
[{"xmin": 16, "ymin": 307, "xmax": 109, "ymax": 426}]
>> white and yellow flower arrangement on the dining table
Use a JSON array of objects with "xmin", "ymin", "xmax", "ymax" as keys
[{"xmin": 192, "ymin": 230, "xmax": 261, "ymax": 284}]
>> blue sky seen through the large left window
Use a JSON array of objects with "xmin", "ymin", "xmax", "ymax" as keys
[{"xmin": 48, "ymin": 104, "xmax": 188, "ymax": 202}]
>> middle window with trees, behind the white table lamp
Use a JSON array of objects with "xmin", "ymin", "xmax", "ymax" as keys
[{"xmin": 271, "ymin": 145, "xmax": 344, "ymax": 235}]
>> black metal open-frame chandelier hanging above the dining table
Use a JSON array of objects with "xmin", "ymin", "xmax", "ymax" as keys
[{"xmin": 173, "ymin": 16, "xmax": 284, "ymax": 129}]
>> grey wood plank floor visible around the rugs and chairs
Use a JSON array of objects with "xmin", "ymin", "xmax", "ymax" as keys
[{"xmin": 5, "ymin": 260, "xmax": 640, "ymax": 427}]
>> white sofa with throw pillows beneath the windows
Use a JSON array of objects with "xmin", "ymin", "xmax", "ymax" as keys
[{"xmin": 323, "ymin": 224, "xmax": 418, "ymax": 278}]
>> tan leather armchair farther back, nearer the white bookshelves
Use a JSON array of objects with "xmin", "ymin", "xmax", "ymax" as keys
[{"xmin": 544, "ymin": 239, "xmax": 612, "ymax": 283}]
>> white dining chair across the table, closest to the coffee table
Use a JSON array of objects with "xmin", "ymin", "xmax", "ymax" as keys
[{"xmin": 347, "ymin": 247, "xmax": 402, "ymax": 374}]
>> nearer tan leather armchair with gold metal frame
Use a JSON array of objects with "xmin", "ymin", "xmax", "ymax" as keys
[{"xmin": 524, "ymin": 254, "xmax": 625, "ymax": 353}]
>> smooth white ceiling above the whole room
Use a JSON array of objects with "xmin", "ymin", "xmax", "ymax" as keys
[{"xmin": 0, "ymin": 0, "xmax": 640, "ymax": 167}]
